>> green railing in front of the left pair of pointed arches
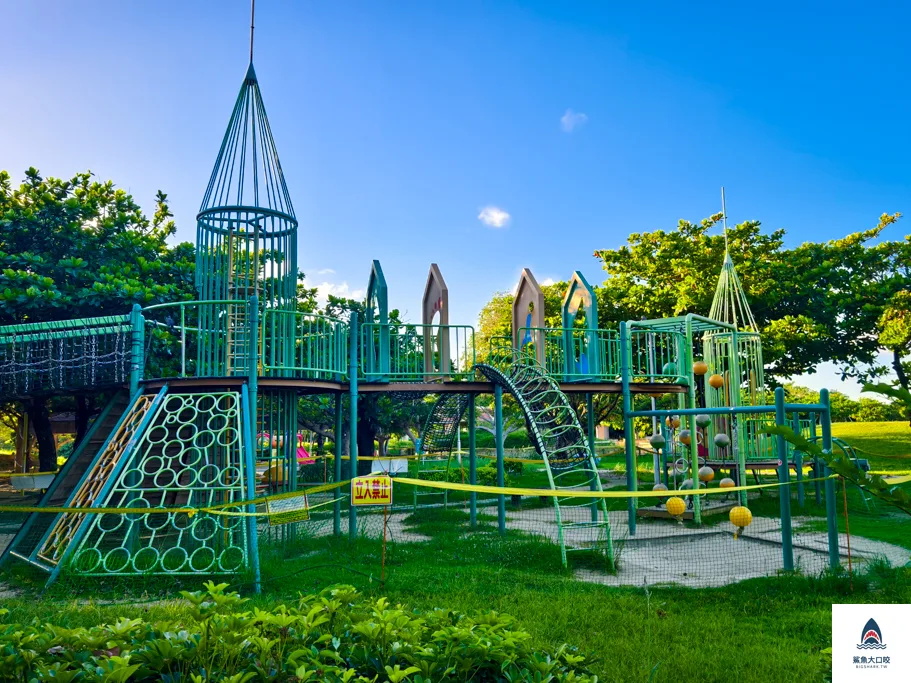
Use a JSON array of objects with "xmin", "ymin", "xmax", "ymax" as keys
[{"xmin": 360, "ymin": 323, "xmax": 475, "ymax": 382}]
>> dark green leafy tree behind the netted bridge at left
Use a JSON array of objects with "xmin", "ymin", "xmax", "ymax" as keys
[{"xmin": 0, "ymin": 168, "xmax": 194, "ymax": 471}]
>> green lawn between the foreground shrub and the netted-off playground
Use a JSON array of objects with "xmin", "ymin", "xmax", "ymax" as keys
[{"xmin": 4, "ymin": 501, "xmax": 911, "ymax": 683}]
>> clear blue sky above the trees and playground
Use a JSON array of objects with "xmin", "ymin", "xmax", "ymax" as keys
[{"xmin": 0, "ymin": 0, "xmax": 911, "ymax": 393}]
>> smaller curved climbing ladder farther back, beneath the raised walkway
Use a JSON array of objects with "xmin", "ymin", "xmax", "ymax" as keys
[{"xmin": 414, "ymin": 394, "xmax": 471, "ymax": 511}]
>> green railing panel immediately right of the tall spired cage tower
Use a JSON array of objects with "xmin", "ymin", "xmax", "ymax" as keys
[{"xmin": 260, "ymin": 309, "xmax": 349, "ymax": 381}]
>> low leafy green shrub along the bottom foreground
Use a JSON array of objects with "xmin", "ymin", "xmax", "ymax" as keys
[{"xmin": 0, "ymin": 582, "xmax": 597, "ymax": 683}]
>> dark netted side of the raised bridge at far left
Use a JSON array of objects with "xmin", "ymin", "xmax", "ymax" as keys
[{"xmin": 0, "ymin": 316, "xmax": 131, "ymax": 398}]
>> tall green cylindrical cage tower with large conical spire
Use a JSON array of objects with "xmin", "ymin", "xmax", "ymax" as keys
[{"xmin": 196, "ymin": 63, "xmax": 298, "ymax": 375}]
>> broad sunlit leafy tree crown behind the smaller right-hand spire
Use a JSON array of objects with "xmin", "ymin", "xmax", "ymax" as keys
[{"xmin": 595, "ymin": 214, "xmax": 911, "ymax": 379}]
